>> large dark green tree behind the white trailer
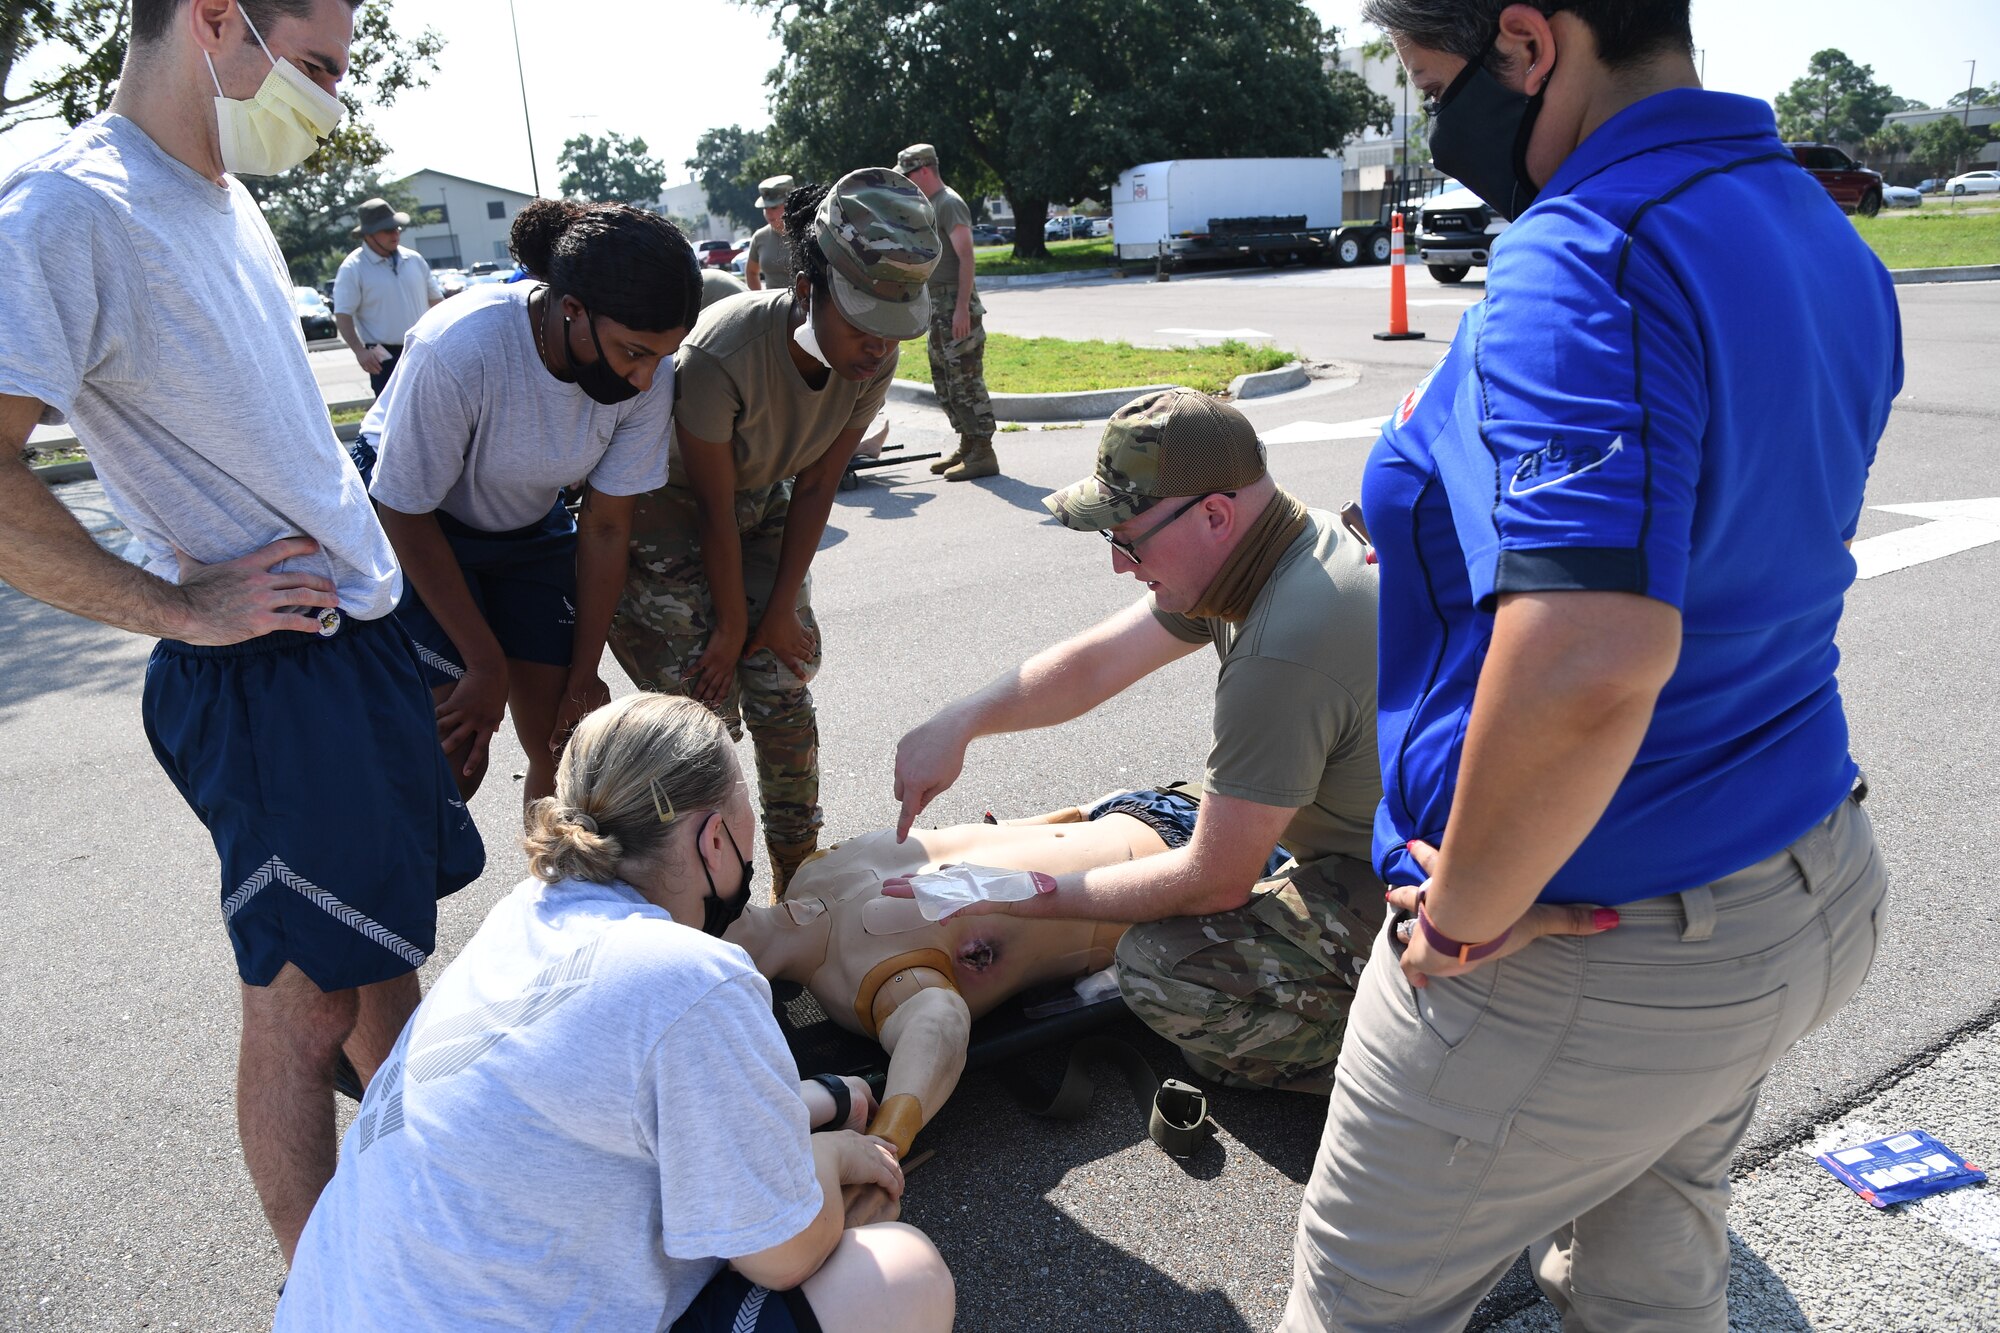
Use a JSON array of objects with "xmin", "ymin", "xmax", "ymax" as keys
[{"xmin": 746, "ymin": 0, "xmax": 1394, "ymax": 254}]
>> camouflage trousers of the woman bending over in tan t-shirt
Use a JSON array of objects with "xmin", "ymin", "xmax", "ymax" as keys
[{"xmin": 610, "ymin": 480, "xmax": 822, "ymax": 845}]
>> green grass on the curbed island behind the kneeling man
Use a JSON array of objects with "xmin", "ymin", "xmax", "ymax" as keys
[{"xmin": 896, "ymin": 334, "xmax": 1296, "ymax": 394}]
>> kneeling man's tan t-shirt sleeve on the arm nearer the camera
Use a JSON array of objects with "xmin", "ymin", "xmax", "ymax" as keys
[{"xmin": 1202, "ymin": 656, "xmax": 1354, "ymax": 811}]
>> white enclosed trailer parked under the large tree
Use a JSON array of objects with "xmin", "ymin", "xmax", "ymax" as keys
[{"xmin": 1112, "ymin": 156, "xmax": 1342, "ymax": 260}]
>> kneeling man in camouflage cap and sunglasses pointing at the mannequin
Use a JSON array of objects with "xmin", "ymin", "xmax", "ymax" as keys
[{"xmin": 896, "ymin": 388, "xmax": 1384, "ymax": 1093}]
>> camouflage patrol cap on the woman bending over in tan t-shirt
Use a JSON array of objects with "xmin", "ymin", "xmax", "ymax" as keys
[{"xmin": 812, "ymin": 166, "xmax": 938, "ymax": 342}]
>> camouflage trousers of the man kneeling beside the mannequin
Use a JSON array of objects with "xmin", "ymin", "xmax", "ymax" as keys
[{"xmin": 1118, "ymin": 857, "xmax": 1388, "ymax": 1093}]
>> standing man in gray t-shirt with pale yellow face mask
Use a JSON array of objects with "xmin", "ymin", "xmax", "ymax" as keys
[{"xmin": 0, "ymin": 0, "xmax": 484, "ymax": 1257}]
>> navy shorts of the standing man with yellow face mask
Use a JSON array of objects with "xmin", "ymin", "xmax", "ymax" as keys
[{"xmin": 144, "ymin": 616, "xmax": 486, "ymax": 991}]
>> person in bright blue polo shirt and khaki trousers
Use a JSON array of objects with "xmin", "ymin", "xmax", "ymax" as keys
[{"xmin": 1282, "ymin": 0, "xmax": 1902, "ymax": 1333}]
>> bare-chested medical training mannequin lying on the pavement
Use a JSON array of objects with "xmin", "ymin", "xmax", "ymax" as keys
[{"xmin": 724, "ymin": 811, "xmax": 1168, "ymax": 1157}]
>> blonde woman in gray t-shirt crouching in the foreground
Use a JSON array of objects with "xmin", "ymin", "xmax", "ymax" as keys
[{"xmin": 276, "ymin": 695, "xmax": 952, "ymax": 1333}]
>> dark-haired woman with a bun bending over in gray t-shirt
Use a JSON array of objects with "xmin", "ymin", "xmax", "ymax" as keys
[{"xmin": 370, "ymin": 198, "xmax": 702, "ymax": 803}]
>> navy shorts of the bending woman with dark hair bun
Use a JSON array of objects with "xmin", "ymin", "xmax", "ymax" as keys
[{"xmin": 396, "ymin": 500, "xmax": 576, "ymax": 687}]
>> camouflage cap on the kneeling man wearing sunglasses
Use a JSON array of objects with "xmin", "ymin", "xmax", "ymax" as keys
[{"xmin": 1042, "ymin": 388, "xmax": 1264, "ymax": 532}]
